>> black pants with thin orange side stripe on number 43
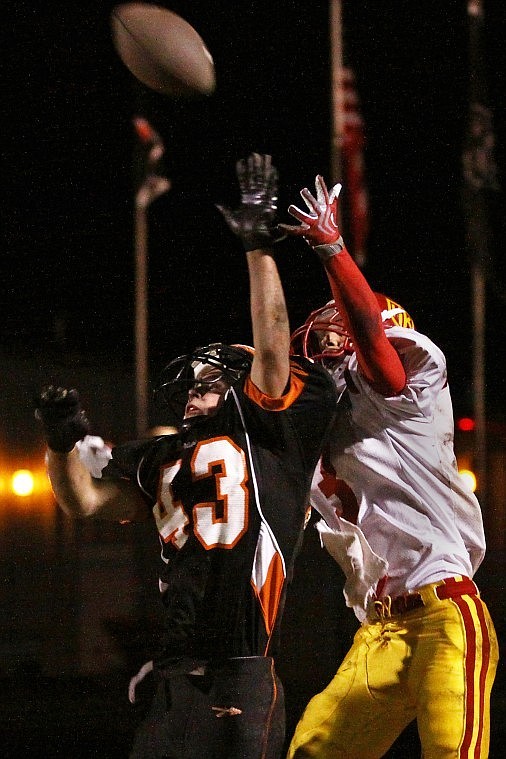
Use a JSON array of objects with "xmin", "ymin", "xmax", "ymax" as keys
[{"xmin": 130, "ymin": 656, "xmax": 285, "ymax": 759}]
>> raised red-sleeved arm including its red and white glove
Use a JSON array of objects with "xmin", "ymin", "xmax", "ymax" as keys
[{"xmin": 279, "ymin": 176, "xmax": 406, "ymax": 395}]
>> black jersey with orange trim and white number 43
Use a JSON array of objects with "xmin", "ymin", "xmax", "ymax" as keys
[{"xmin": 104, "ymin": 357, "xmax": 335, "ymax": 660}]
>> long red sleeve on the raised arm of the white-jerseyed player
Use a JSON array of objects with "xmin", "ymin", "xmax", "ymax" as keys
[{"xmin": 325, "ymin": 248, "xmax": 406, "ymax": 396}]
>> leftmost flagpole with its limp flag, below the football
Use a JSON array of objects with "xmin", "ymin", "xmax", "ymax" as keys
[{"xmin": 133, "ymin": 116, "xmax": 171, "ymax": 437}]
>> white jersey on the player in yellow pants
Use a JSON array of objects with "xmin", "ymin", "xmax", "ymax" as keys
[{"xmin": 311, "ymin": 327, "xmax": 485, "ymax": 619}]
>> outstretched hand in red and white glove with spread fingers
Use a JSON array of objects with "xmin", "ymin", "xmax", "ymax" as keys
[{"xmin": 278, "ymin": 174, "xmax": 342, "ymax": 248}]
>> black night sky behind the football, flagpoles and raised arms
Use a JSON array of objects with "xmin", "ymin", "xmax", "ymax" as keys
[{"xmin": 0, "ymin": 0, "xmax": 506, "ymax": 416}]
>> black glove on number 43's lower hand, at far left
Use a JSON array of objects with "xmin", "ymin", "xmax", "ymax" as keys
[{"xmin": 35, "ymin": 385, "xmax": 90, "ymax": 453}]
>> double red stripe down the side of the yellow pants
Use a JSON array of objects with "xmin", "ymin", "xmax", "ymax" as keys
[{"xmin": 453, "ymin": 596, "xmax": 490, "ymax": 759}]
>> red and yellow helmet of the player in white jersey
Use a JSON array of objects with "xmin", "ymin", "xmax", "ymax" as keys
[{"xmin": 291, "ymin": 293, "xmax": 415, "ymax": 364}]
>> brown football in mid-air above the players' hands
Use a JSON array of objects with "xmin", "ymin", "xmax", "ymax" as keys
[{"xmin": 111, "ymin": 3, "xmax": 216, "ymax": 96}]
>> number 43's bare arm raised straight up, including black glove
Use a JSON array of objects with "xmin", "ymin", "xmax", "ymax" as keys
[{"xmin": 218, "ymin": 153, "xmax": 290, "ymax": 398}]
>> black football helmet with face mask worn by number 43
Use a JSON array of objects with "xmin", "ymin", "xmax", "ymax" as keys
[{"xmin": 155, "ymin": 343, "xmax": 254, "ymax": 420}]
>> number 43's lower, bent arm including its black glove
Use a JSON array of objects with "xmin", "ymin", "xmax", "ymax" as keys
[{"xmin": 35, "ymin": 386, "xmax": 149, "ymax": 521}]
